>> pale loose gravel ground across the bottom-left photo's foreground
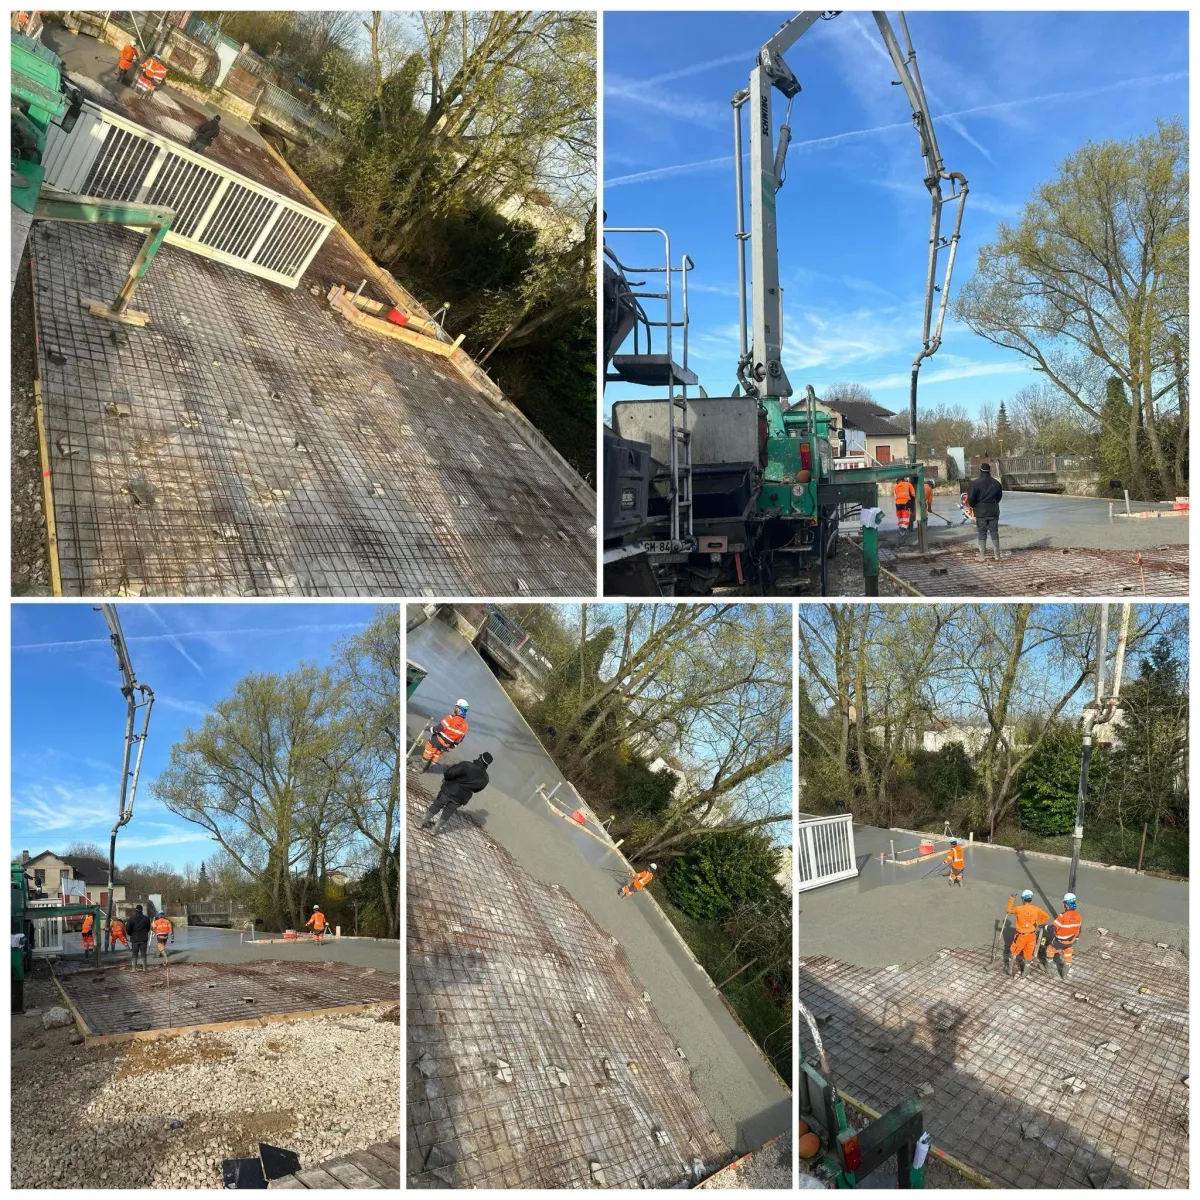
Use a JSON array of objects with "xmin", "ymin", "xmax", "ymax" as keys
[{"xmin": 11, "ymin": 979, "xmax": 401, "ymax": 1188}]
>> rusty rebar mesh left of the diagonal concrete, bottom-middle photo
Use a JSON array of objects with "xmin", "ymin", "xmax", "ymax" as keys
[{"xmin": 407, "ymin": 776, "xmax": 728, "ymax": 1188}]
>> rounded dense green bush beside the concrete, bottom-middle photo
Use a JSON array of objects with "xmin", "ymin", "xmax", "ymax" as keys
[{"xmin": 664, "ymin": 833, "xmax": 779, "ymax": 920}]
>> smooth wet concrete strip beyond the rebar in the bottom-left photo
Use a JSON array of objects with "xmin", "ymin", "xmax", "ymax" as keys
[{"xmin": 62, "ymin": 925, "xmax": 400, "ymax": 974}]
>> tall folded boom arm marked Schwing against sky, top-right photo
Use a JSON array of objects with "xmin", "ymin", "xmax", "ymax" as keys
[{"xmin": 733, "ymin": 12, "xmax": 967, "ymax": 463}]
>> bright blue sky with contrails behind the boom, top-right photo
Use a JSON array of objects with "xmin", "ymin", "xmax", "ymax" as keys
[{"xmin": 604, "ymin": 12, "xmax": 1188, "ymax": 415}]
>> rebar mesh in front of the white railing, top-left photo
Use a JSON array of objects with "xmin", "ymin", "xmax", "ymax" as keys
[{"xmin": 30, "ymin": 223, "xmax": 595, "ymax": 595}]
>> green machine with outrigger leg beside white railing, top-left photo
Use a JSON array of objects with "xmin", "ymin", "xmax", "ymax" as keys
[{"xmin": 11, "ymin": 32, "xmax": 175, "ymax": 325}]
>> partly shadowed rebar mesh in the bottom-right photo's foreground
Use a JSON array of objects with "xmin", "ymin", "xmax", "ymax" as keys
[{"xmin": 797, "ymin": 935, "xmax": 1188, "ymax": 1188}]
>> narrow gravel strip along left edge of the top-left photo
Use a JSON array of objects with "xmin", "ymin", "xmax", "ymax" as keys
[{"xmin": 8, "ymin": 254, "xmax": 50, "ymax": 595}]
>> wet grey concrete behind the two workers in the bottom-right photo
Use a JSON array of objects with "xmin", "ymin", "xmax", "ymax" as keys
[{"xmin": 799, "ymin": 824, "xmax": 1188, "ymax": 966}]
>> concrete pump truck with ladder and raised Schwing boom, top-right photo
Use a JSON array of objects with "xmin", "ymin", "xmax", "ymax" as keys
[{"xmin": 604, "ymin": 12, "xmax": 967, "ymax": 595}]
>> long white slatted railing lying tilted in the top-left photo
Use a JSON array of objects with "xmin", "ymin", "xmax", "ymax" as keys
[{"xmin": 43, "ymin": 102, "xmax": 336, "ymax": 288}]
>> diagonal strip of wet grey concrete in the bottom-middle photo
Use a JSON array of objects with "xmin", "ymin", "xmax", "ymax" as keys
[{"xmin": 406, "ymin": 620, "xmax": 791, "ymax": 1153}]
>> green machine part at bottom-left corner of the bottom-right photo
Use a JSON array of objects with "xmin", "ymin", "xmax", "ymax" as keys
[{"xmin": 797, "ymin": 1002, "xmax": 929, "ymax": 1188}]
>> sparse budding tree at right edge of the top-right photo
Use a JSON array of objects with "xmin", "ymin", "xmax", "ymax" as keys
[{"xmin": 955, "ymin": 119, "xmax": 1189, "ymax": 497}]
